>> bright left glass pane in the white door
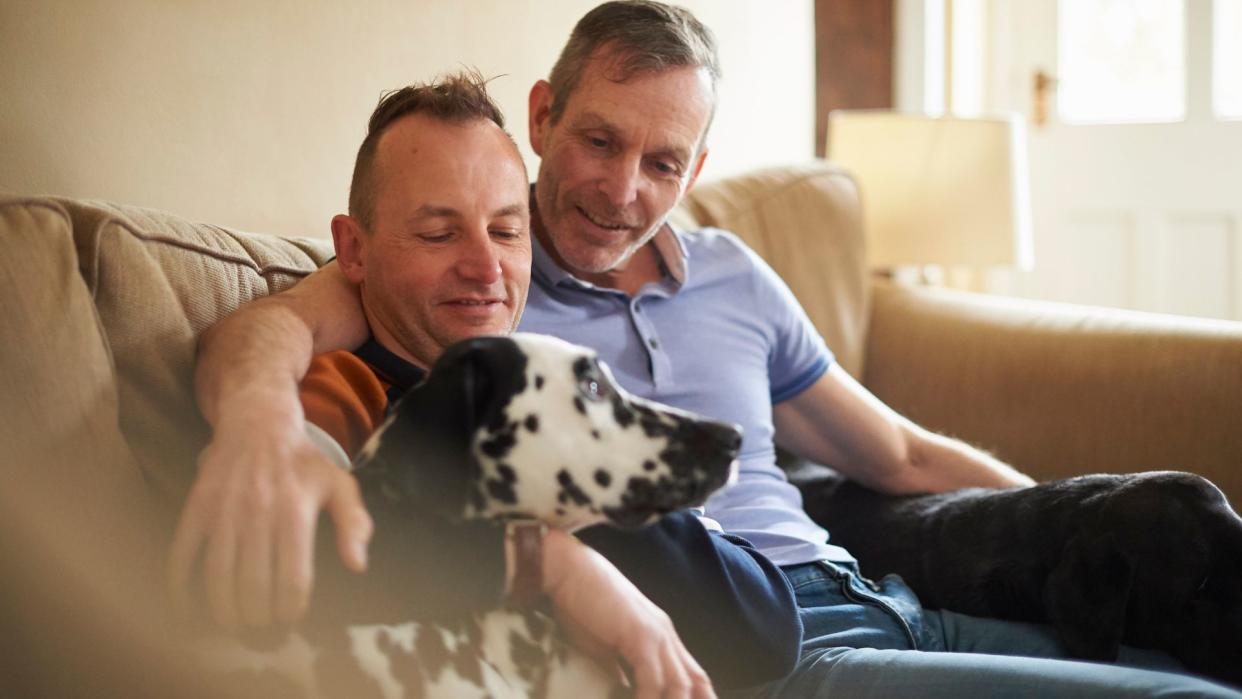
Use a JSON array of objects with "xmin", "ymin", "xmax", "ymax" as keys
[{"xmin": 1057, "ymin": 0, "xmax": 1182, "ymax": 123}]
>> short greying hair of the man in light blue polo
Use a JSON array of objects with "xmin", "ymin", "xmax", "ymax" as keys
[{"xmin": 548, "ymin": 0, "xmax": 720, "ymax": 124}]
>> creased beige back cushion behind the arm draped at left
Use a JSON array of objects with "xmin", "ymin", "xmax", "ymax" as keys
[{"xmin": 60, "ymin": 200, "xmax": 332, "ymax": 499}]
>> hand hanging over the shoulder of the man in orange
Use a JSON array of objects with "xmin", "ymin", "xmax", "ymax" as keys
[{"xmin": 169, "ymin": 399, "xmax": 373, "ymax": 629}]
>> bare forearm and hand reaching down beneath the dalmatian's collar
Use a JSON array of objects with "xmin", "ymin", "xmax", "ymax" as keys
[{"xmin": 543, "ymin": 529, "xmax": 715, "ymax": 699}]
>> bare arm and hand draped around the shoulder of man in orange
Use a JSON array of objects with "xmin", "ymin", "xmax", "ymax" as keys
[{"xmin": 169, "ymin": 262, "xmax": 371, "ymax": 628}]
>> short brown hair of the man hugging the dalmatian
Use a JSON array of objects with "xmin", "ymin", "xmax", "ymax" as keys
[{"xmin": 349, "ymin": 70, "xmax": 513, "ymax": 231}]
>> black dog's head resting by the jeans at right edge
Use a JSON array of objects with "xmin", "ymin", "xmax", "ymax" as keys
[{"xmin": 1049, "ymin": 472, "xmax": 1242, "ymax": 683}]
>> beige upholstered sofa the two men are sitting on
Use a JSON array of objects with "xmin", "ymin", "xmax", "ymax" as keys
[{"xmin": 0, "ymin": 163, "xmax": 1242, "ymax": 697}]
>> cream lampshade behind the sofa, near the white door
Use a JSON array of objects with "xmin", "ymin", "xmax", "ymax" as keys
[{"xmin": 827, "ymin": 110, "xmax": 1035, "ymax": 269}]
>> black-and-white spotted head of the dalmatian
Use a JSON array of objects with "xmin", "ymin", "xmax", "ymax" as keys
[{"xmin": 358, "ymin": 333, "xmax": 741, "ymax": 529}]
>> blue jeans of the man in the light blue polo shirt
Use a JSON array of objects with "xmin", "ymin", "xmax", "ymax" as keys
[{"xmin": 738, "ymin": 561, "xmax": 1242, "ymax": 699}]
